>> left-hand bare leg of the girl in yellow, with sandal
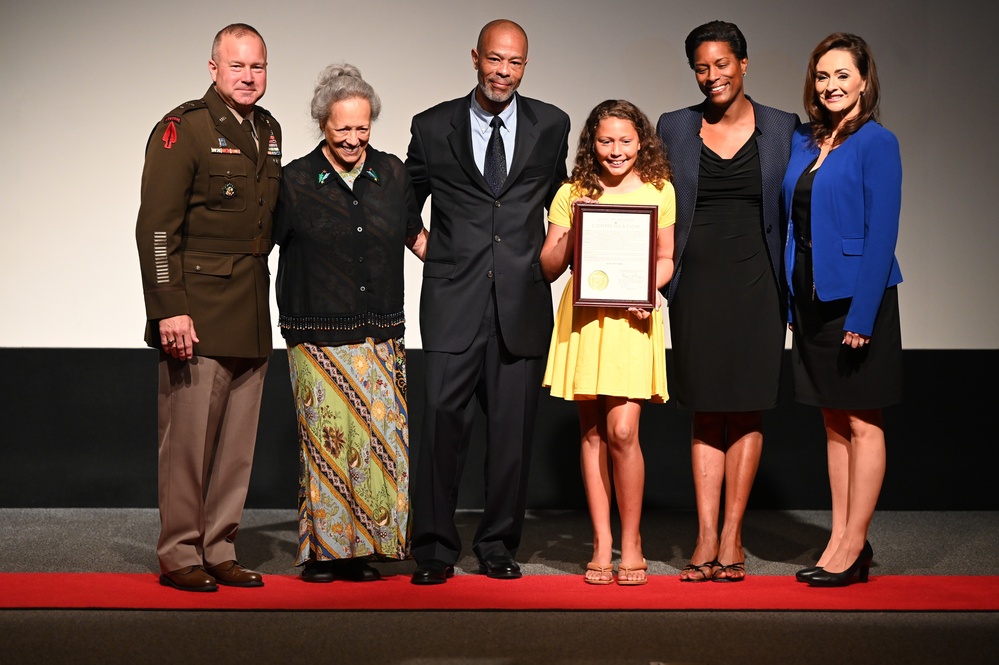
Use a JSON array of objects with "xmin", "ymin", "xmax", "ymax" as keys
[{"xmin": 577, "ymin": 397, "xmax": 614, "ymax": 581}]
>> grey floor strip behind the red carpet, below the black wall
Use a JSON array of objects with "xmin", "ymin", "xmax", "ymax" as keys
[{"xmin": 0, "ymin": 509, "xmax": 999, "ymax": 575}]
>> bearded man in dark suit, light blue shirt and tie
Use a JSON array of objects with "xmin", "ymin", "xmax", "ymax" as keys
[{"xmin": 406, "ymin": 20, "xmax": 569, "ymax": 584}]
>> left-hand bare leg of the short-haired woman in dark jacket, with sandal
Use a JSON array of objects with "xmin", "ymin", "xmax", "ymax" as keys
[{"xmin": 680, "ymin": 412, "xmax": 726, "ymax": 581}]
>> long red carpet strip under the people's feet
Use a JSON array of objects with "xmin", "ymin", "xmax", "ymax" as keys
[{"xmin": 0, "ymin": 573, "xmax": 999, "ymax": 612}]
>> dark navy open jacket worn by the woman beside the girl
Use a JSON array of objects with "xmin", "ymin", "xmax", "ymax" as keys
[{"xmin": 656, "ymin": 100, "xmax": 801, "ymax": 302}]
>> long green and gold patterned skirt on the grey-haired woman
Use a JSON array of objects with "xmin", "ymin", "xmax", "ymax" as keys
[{"xmin": 288, "ymin": 338, "xmax": 410, "ymax": 565}]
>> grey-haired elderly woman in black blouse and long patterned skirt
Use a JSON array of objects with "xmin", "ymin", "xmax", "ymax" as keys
[{"xmin": 274, "ymin": 64, "xmax": 426, "ymax": 582}]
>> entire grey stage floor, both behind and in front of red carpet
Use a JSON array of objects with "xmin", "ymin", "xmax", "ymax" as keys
[{"xmin": 0, "ymin": 509, "xmax": 999, "ymax": 665}]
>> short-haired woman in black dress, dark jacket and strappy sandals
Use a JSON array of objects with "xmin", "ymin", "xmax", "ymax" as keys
[{"xmin": 659, "ymin": 21, "xmax": 800, "ymax": 582}]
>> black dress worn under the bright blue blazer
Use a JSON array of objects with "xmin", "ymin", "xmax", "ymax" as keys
[{"xmin": 791, "ymin": 162, "xmax": 902, "ymax": 410}]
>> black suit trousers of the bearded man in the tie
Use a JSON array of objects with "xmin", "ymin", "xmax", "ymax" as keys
[{"xmin": 412, "ymin": 296, "xmax": 545, "ymax": 564}]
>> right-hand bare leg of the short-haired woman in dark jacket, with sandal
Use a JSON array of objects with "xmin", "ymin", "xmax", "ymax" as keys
[{"xmin": 718, "ymin": 411, "xmax": 763, "ymax": 579}]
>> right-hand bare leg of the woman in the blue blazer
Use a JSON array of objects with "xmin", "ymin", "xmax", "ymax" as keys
[{"xmin": 822, "ymin": 409, "xmax": 887, "ymax": 573}]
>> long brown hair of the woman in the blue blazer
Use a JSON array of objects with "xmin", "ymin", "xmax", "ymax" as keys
[{"xmin": 803, "ymin": 32, "xmax": 881, "ymax": 145}]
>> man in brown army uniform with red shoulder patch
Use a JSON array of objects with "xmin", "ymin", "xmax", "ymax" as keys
[{"xmin": 135, "ymin": 24, "xmax": 281, "ymax": 591}]
